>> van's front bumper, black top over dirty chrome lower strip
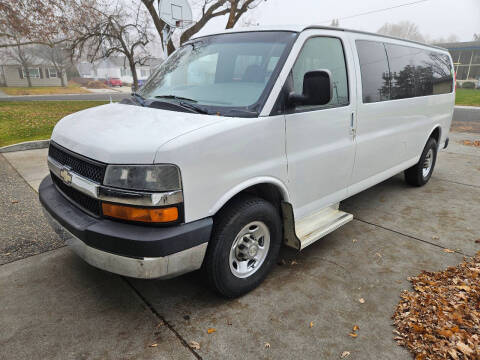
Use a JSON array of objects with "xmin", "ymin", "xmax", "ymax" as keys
[{"xmin": 39, "ymin": 176, "xmax": 213, "ymax": 279}]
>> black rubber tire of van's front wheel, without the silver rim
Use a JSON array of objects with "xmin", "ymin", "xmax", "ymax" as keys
[{"xmin": 204, "ymin": 195, "xmax": 282, "ymax": 298}]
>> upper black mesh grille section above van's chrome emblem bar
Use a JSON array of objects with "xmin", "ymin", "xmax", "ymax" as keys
[{"xmin": 48, "ymin": 142, "xmax": 107, "ymax": 184}]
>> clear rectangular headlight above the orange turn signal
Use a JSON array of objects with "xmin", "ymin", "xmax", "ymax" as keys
[{"xmin": 103, "ymin": 165, "xmax": 182, "ymax": 192}]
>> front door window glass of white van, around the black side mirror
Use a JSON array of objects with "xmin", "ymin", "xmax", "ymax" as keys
[{"xmin": 292, "ymin": 37, "xmax": 349, "ymax": 110}]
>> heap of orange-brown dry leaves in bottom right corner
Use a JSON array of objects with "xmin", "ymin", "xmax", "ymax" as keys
[{"xmin": 393, "ymin": 252, "xmax": 480, "ymax": 360}]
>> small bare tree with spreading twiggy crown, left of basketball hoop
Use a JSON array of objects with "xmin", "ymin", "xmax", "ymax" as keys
[{"xmin": 71, "ymin": 1, "xmax": 152, "ymax": 89}]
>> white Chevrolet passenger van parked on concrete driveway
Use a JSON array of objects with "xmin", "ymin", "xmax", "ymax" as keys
[{"xmin": 39, "ymin": 26, "xmax": 455, "ymax": 297}]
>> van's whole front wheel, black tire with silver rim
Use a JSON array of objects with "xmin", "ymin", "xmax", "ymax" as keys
[{"xmin": 204, "ymin": 196, "xmax": 282, "ymax": 298}]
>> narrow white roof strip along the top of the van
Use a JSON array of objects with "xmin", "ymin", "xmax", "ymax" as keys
[{"xmin": 192, "ymin": 25, "xmax": 448, "ymax": 52}]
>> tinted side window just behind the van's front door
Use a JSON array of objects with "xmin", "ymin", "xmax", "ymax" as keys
[{"xmin": 356, "ymin": 40, "xmax": 390, "ymax": 103}]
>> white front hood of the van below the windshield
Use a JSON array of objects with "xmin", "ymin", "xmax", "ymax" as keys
[{"xmin": 52, "ymin": 104, "xmax": 222, "ymax": 164}]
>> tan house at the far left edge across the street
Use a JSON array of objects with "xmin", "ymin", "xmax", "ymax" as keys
[{"xmin": 0, "ymin": 58, "xmax": 67, "ymax": 87}]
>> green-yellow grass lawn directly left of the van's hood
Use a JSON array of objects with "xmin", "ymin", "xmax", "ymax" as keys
[{"xmin": 0, "ymin": 101, "xmax": 106, "ymax": 146}]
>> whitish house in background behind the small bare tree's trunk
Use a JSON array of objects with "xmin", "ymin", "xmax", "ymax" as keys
[{"xmin": 77, "ymin": 56, "xmax": 162, "ymax": 84}]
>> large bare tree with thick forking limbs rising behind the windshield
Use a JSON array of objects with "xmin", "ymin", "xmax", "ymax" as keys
[{"xmin": 142, "ymin": 0, "xmax": 266, "ymax": 54}]
